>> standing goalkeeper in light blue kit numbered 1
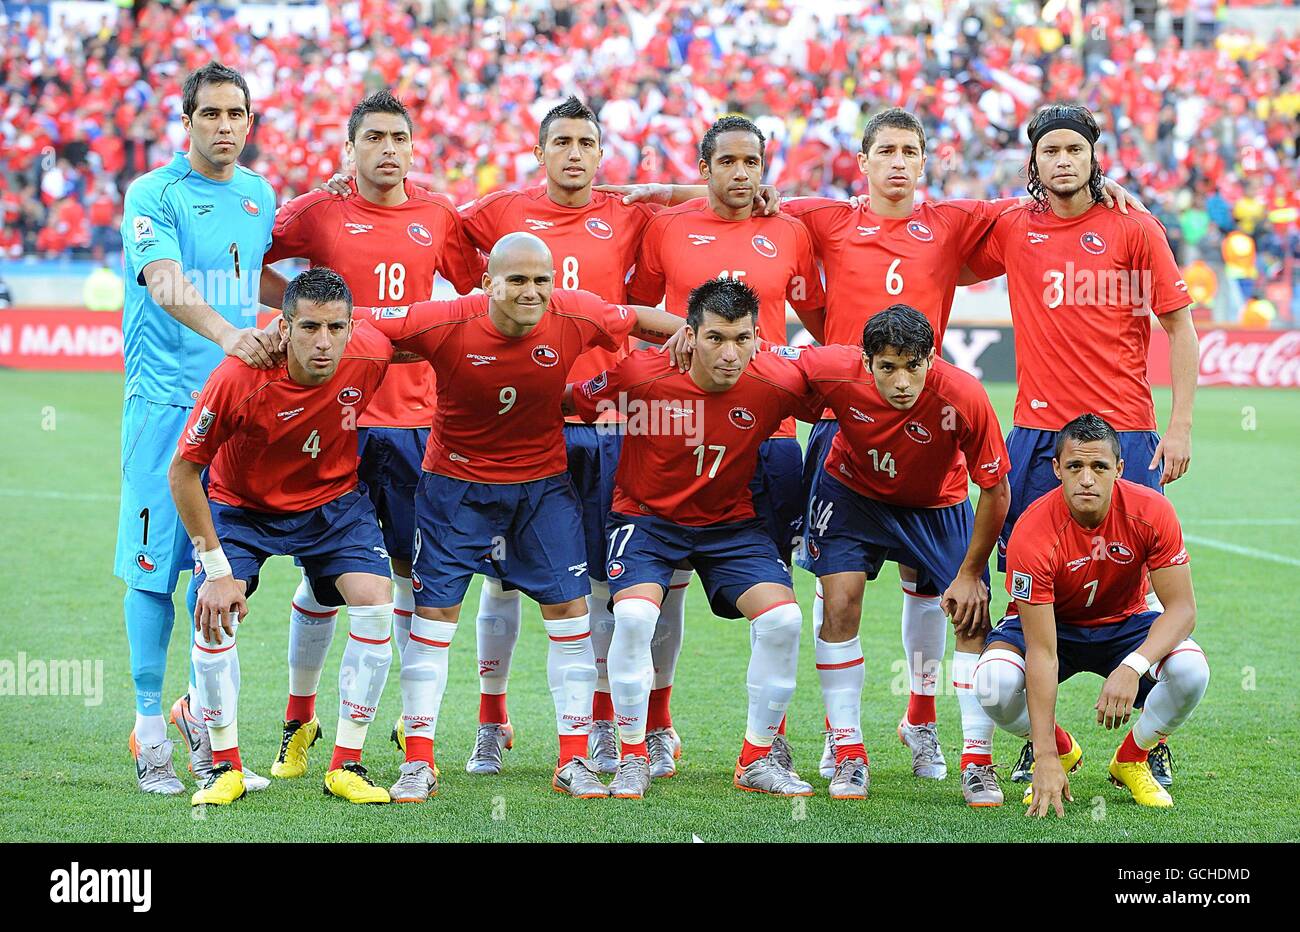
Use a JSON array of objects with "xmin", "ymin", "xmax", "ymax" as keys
[{"xmin": 113, "ymin": 62, "xmax": 282, "ymax": 794}]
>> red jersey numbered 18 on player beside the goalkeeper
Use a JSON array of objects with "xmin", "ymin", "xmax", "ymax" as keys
[{"xmin": 263, "ymin": 181, "xmax": 484, "ymax": 428}]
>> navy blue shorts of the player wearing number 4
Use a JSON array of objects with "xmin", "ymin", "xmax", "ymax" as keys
[{"xmin": 194, "ymin": 486, "xmax": 389, "ymax": 606}]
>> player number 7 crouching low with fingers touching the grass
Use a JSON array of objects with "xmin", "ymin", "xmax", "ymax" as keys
[{"xmin": 975, "ymin": 413, "xmax": 1210, "ymax": 816}]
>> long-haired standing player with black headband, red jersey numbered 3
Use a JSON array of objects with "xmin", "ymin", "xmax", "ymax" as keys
[{"xmin": 969, "ymin": 105, "xmax": 1200, "ymax": 783}]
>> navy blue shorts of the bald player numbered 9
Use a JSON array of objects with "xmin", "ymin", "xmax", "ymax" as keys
[{"xmin": 411, "ymin": 472, "xmax": 592, "ymax": 608}]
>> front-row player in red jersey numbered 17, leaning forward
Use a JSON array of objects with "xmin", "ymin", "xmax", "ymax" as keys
[{"xmin": 566, "ymin": 277, "xmax": 816, "ymax": 798}]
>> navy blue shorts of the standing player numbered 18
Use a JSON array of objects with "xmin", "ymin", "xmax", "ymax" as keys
[{"xmin": 356, "ymin": 428, "xmax": 429, "ymax": 563}]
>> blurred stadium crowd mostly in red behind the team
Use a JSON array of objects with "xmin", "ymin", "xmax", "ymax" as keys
[{"xmin": 0, "ymin": 0, "xmax": 1300, "ymax": 292}]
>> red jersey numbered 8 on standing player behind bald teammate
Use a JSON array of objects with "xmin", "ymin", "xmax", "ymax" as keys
[{"xmin": 460, "ymin": 185, "xmax": 660, "ymax": 420}]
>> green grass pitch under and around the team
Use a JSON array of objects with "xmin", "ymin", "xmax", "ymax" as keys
[{"xmin": 0, "ymin": 372, "xmax": 1300, "ymax": 841}]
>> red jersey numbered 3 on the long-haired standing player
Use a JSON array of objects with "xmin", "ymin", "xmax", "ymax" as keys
[{"xmin": 969, "ymin": 204, "xmax": 1190, "ymax": 430}]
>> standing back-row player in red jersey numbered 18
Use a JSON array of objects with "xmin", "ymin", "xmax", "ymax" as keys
[{"xmin": 253, "ymin": 91, "xmax": 482, "ymax": 777}]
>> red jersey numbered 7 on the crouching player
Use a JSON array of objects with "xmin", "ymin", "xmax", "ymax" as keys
[{"xmin": 1006, "ymin": 478, "xmax": 1188, "ymax": 628}]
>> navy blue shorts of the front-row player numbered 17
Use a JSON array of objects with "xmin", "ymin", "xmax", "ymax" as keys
[{"xmin": 605, "ymin": 512, "xmax": 793, "ymax": 619}]
